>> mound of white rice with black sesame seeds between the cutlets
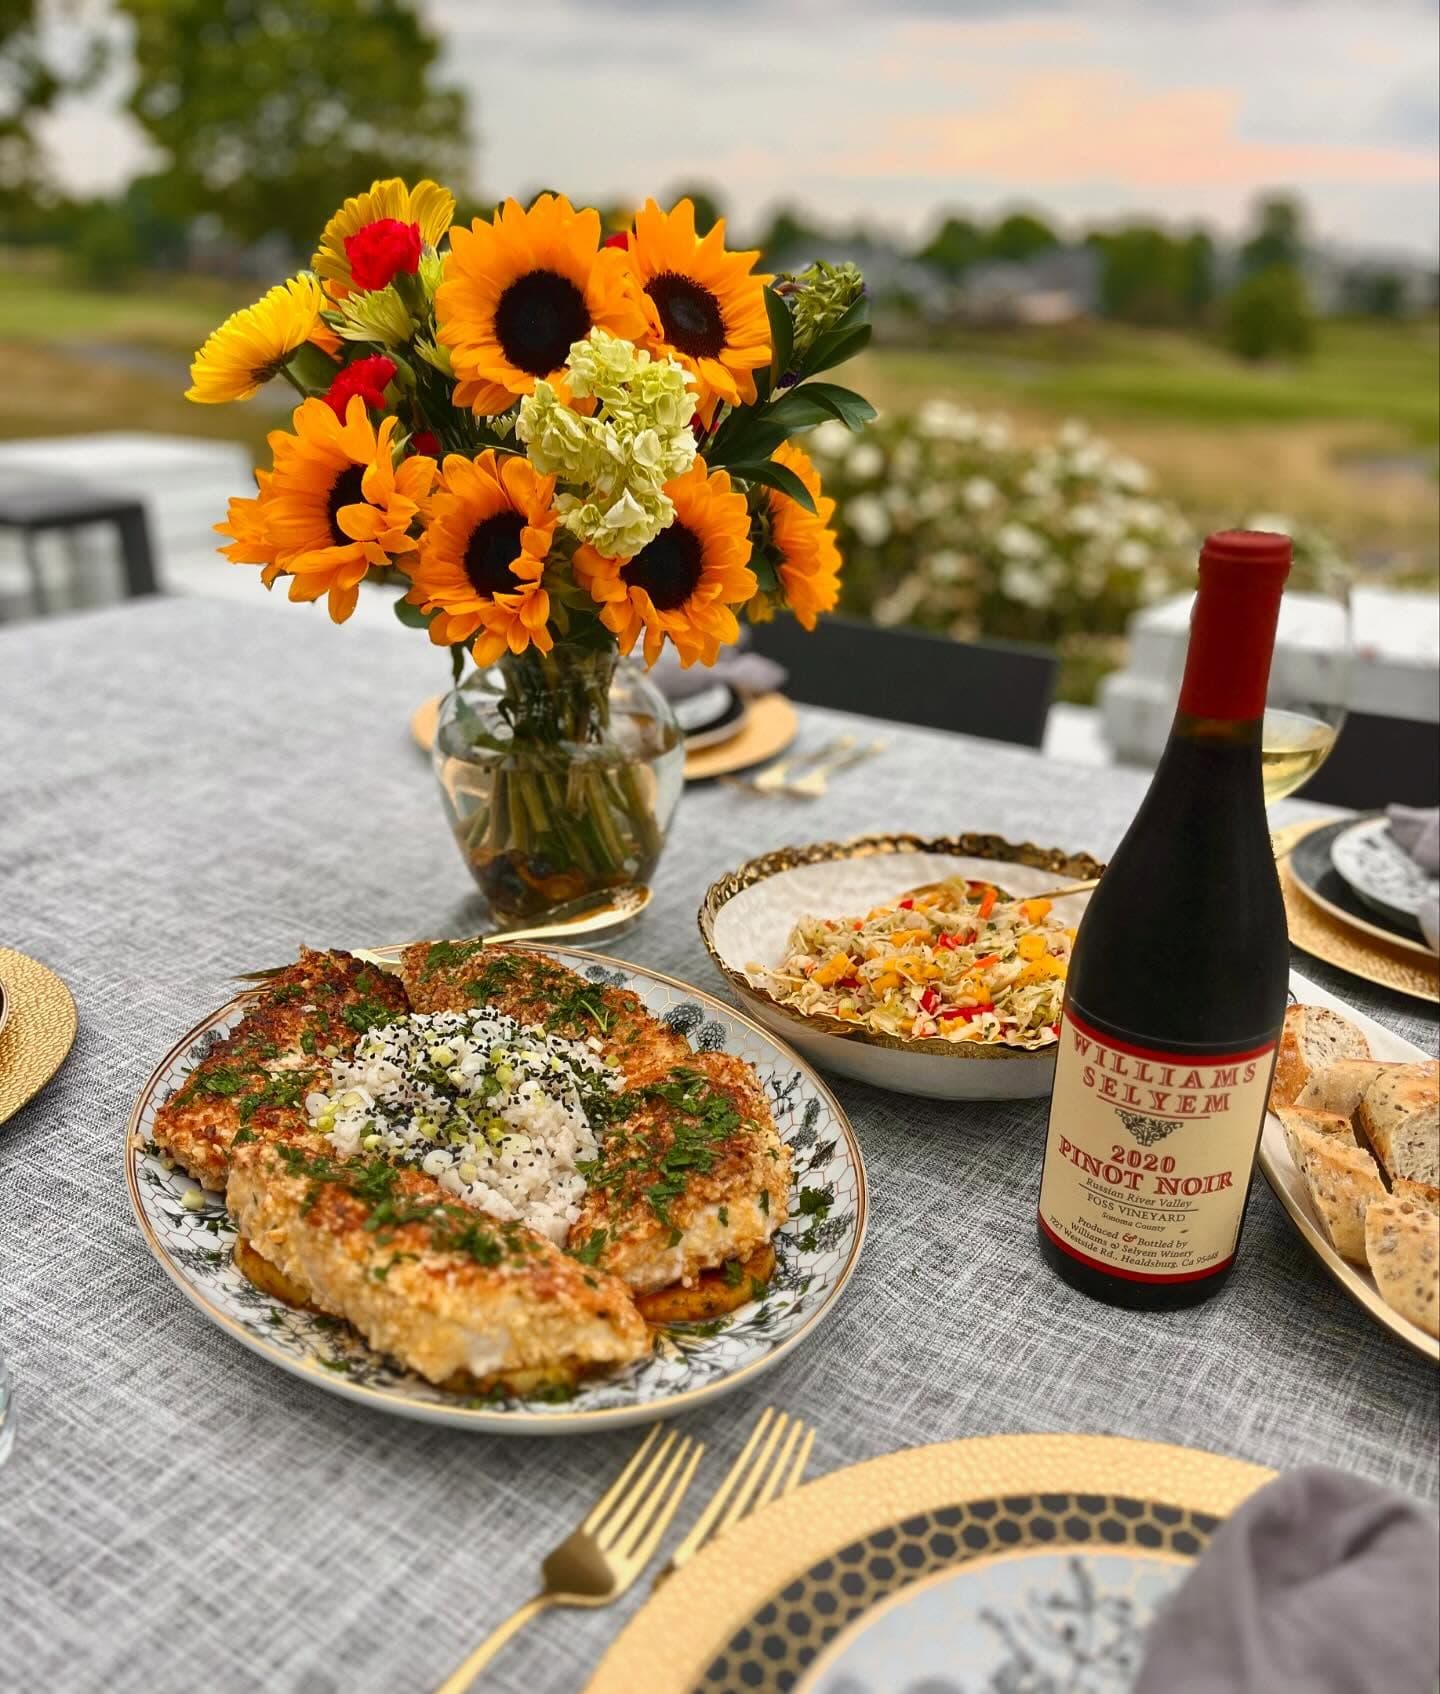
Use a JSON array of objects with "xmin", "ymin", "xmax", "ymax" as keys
[{"xmin": 305, "ymin": 1008, "xmax": 620, "ymax": 1245}]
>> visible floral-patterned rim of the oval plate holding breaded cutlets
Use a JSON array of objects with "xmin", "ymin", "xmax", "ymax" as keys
[{"xmin": 125, "ymin": 947, "xmax": 866, "ymax": 1435}]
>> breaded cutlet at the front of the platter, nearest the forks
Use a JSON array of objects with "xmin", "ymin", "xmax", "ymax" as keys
[{"xmin": 225, "ymin": 1111, "xmax": 651, "ymax": 1392}]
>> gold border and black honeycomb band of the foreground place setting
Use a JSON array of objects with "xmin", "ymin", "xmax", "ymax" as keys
[{"xmin": 586, "ymin": 1435, "xmax": 1274, "ymax": 1694}]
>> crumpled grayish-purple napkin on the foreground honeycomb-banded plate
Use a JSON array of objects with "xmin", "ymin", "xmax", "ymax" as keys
[{"xmin": 1133, "ymin": 1467, "xmax": 1440, "ymax": 1694}]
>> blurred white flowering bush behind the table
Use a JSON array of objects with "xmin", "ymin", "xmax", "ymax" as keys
[{"xmin": 808, "ymin": 400, "xmax": 1194, "ymax": 701}]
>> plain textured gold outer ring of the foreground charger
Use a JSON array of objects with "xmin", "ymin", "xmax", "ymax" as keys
[{"xmin": 586, "ymin": 1435, "xmax": 1274, "ymax": 1694}]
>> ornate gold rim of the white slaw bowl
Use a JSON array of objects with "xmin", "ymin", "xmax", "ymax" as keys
[{"xmin": 696, "ymin": 833, "xmax": 1105, "ymax": 1062}]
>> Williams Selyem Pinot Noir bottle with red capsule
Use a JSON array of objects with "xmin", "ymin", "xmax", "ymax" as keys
[{"xmin": 1038, "ymin": 530, "xmax": 1291, "ymax": 1309}]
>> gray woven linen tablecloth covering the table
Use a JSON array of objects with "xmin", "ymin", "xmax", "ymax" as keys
[{"xmin": 0, "ymin": 601, "xmax": 1437, "ymax": 1694}]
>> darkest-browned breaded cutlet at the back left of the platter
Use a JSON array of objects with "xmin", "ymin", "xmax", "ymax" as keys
[{"xmin": 151, "ymin": 947, "xmax": 410, "ymax": 1189}]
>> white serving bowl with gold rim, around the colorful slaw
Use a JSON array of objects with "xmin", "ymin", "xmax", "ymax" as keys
[{"xmin": 700, "ymin": 833, "xmax": 1105, "ymax": 1099}]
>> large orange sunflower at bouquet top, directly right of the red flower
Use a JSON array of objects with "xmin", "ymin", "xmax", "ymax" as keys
[{"xmin": 435, "ymin": 195, "xmax": 645, "ymax": 417}]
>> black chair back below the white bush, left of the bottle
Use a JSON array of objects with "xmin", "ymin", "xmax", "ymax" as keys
[{"xmin": 750, "ymin": 617, "xmax": 1057, "ymax": 747}]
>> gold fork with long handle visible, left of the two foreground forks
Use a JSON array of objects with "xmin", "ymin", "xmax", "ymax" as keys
[{"xmin": 426, "ymin": 1425, "xmax": 705, "ymax": 1694}]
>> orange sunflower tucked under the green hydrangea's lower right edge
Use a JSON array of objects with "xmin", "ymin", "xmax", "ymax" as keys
[{"xmin": 574, "ymin": 459, "xmax": 757, "ymax": 666}]
